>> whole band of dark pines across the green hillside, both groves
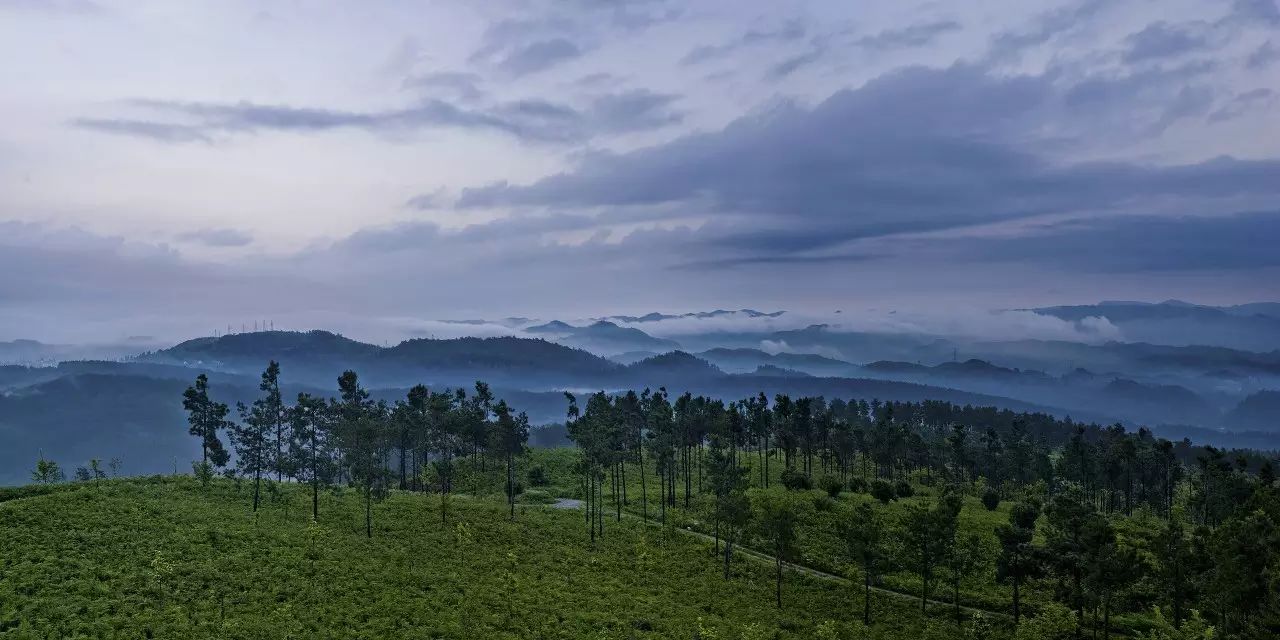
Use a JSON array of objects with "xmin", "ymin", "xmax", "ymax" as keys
[{"xmin": 10, "ymin": 361, "xmax": 1280, "ymax": 639}]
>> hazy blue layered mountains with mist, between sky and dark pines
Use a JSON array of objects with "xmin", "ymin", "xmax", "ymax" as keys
[{"xmin": 0, "ymin": 296, "xmax": 1280, "ymax": 484}]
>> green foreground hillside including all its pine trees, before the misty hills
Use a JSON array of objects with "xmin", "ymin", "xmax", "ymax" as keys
[{"xmin": 0, "ymin": 362, "xmax": 1280, "ymax": 639}]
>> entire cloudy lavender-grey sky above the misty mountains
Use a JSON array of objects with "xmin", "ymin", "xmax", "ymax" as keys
[{"xmin": 0, "ymin": 0, "xmax": 1280, "ymax": 342}]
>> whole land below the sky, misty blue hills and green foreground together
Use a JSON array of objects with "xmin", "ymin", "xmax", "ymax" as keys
[{"xmin": 0, "ymin": 303, "xmax": 1280, "ymax": 639}]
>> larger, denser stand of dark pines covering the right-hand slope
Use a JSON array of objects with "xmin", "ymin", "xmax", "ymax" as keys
[{"xmin": 566, "ymin": 389, "xmax": 1280, "ymax": 637}]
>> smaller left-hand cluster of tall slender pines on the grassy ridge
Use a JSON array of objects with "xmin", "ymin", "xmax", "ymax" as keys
[{"xmin": 174, "ymin": 361, "xmax": 529, "ymax": 536}]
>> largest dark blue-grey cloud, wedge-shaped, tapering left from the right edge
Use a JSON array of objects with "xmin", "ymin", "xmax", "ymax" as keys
[{"xmin": 458, "ymin": 67, "xmax": 1280, "ymax": 260}]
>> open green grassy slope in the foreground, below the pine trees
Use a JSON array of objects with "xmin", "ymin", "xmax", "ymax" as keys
[{"xmin": 0, "ymin": 477, "xmax": 1008, "ymax": 639}]
